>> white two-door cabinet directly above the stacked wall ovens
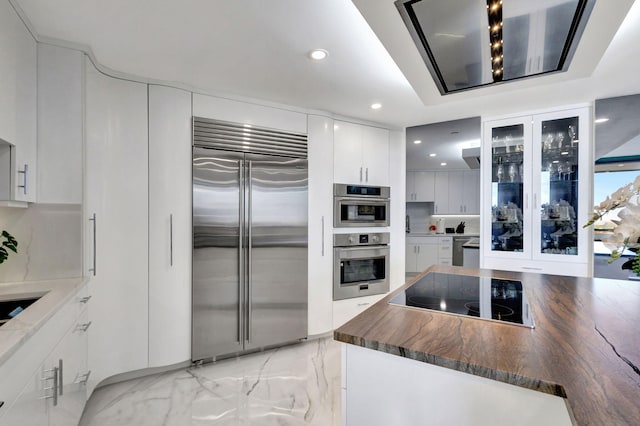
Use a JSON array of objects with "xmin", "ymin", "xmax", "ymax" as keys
[{"xmin": 333, "ymin": 121, "xmax": 389, "ymax": 186}]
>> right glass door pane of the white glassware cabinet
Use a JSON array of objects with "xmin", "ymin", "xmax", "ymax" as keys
[{"xmin": 534, "ymin": 116, "xmax": 580, "ymax": 256}]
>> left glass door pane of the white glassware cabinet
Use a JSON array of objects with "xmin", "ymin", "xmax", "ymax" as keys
[{"xmin": 490, "ymin": 124, "xmax": 530, "ymax": 252}]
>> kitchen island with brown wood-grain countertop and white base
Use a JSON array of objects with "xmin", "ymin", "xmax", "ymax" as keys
[{"xmin": 334, "ymin": 266, "xmax": 640, "ymax": 425}]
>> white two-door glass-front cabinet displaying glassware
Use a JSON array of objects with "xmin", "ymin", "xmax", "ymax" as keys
[{"xmin": 481, "ymin": 107, "xmax": 593, "ymax": 276}]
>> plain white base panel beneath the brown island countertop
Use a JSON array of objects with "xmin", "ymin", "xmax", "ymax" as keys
[{"xmin": 342, "ymin": 344, "xmax": 573, "ymax": 426}]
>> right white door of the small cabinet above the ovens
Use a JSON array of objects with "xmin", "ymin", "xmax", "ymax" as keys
[{"xmin": 362, "ymin": 126, "xmax": 389, "ymax": 186}]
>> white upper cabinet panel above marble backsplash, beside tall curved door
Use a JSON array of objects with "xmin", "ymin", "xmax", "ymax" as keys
[{"xmin": 34, "ymin": 43, "xmax": 84, "ymax": 204}]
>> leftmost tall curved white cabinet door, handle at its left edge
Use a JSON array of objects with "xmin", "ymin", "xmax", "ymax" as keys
[{"xmin": 84, "ymin": 64, "xmax": 149, "ymax": 393}]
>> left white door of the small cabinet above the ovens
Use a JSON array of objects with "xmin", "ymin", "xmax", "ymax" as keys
[{"xmin": 333, "ymin": 121, "xmax": 364, "ymax": 183}]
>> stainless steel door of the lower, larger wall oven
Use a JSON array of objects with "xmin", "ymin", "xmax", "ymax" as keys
[{"xmin": 333, "ymin": 246, "xmax": 389, "ymax": 300}]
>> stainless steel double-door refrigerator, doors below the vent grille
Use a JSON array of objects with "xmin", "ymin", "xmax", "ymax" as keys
[{"xmin": 192, "ymin": 125, "xmax": 308, "ymax": 362}]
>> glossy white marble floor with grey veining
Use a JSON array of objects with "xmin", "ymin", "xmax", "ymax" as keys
[{"xmin": 80, "ymin": 338, "xmax": 341, "ymax": 426}]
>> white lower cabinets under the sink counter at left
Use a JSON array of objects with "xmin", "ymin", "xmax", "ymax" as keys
[{"xmin": 0, "ymin": 289, "xmax": 90, "ymax": 426}]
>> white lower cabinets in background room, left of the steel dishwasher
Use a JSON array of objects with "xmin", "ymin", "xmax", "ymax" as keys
[{"xmin": 405, "ymin": 237, "xmax": 453, "ymax": 272}]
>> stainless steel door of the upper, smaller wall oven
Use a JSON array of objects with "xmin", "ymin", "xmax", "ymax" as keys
[{"xmin": 333, "ymin": 197, "xmax": 389, "ymax": 228}]
